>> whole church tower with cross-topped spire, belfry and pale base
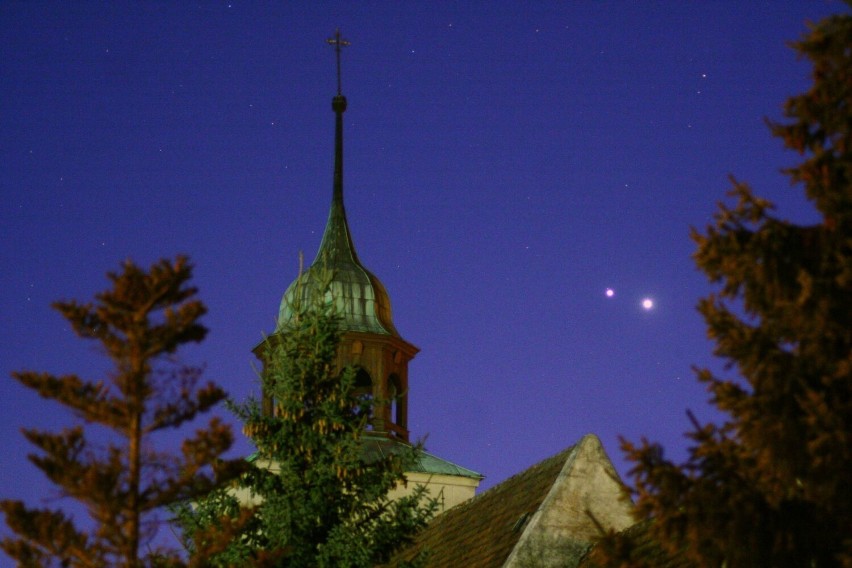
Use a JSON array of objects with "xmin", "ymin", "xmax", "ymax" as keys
[{"xmin": 254, "ymin": 31, "xmax": 483, "ymax": 512}]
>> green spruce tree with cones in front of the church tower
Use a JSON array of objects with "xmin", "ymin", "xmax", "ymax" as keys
[{"xmin": 179, "ymin": 271, "xmax": 436, "ymax": 568}]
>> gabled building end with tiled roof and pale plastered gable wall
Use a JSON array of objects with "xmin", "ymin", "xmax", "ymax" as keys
[{"xmin": 390, "ymin": 435, "xmax": 633, "ymax": 568}]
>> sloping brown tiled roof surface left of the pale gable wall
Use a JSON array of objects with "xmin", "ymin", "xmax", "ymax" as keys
[{"xmin": 392, "ymin": 446, "xmax": 575, "ymax": 568}]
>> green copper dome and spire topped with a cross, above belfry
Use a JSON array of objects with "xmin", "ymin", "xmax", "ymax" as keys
[{"xmin": 278, "ymin": 30, "xmax": 399, "ymax": 337}]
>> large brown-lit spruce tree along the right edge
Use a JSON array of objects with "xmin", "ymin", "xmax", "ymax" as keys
[{"xmin": 592, "ymin": 13, "xmax": 852, "ymax": 568}]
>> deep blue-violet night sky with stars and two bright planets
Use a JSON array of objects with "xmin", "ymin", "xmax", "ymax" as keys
[{"xmin": 0, "ymin": 0, "xmax": 848, "ymax": 552}]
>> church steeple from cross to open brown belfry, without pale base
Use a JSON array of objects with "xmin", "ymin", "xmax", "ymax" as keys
[{"xmin": 256, "ymin": 31, "xmax": 419, "ymax": 441}]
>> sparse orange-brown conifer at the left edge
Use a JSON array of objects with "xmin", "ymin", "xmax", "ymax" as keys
[{"xmin": 0, "ymin": 257, "xmax": 243, "ymax": 567}]
